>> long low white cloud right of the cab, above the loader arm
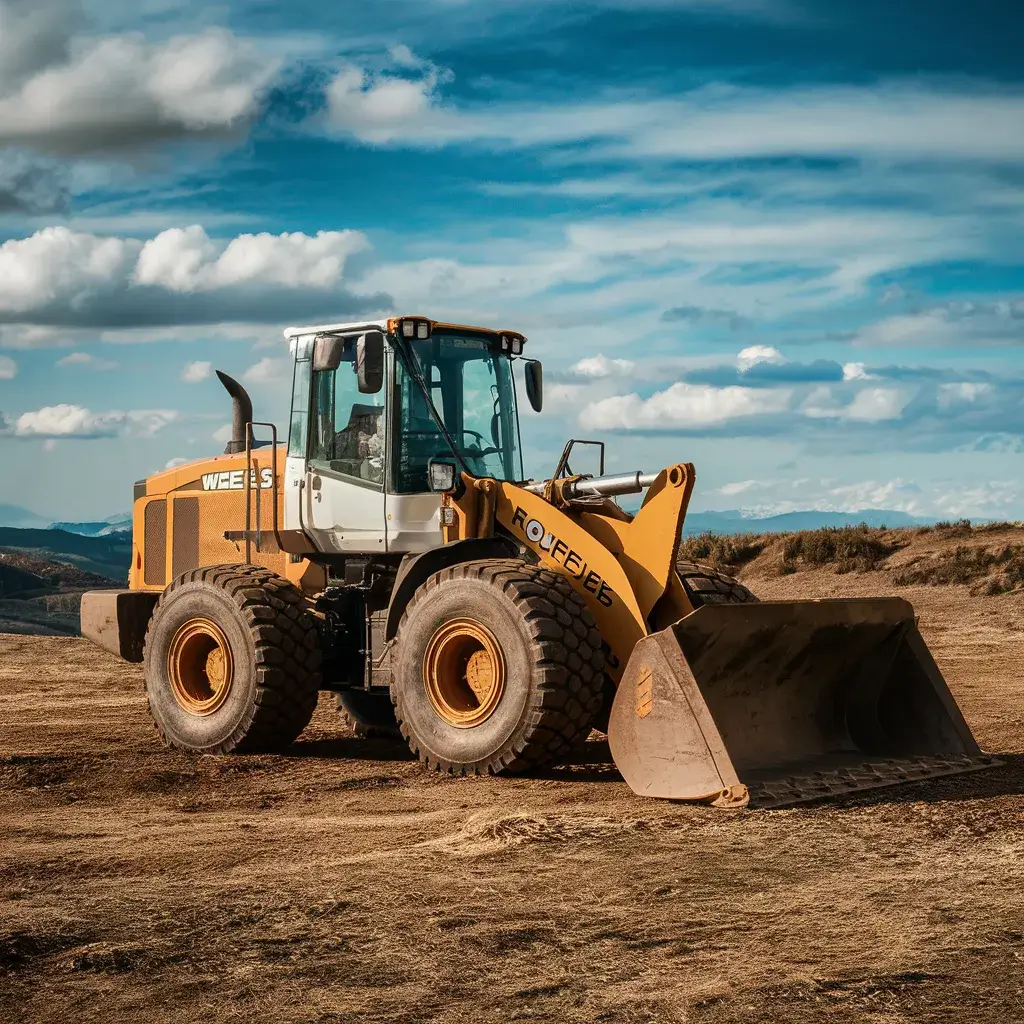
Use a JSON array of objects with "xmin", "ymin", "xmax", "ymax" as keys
[{"xmin": 580, "ymin": 381, "xmax": 792, "ymax": 430}]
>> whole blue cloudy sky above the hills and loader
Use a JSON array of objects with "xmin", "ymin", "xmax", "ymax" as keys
[{"xmin": 0, "ymin": 0, "xmax": 1024, "ymax": 519}]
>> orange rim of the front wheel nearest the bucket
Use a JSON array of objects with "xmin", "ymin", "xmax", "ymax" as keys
[{"xmin": 423, "ymin": 618, "xmax": 505, "ymax": 729}]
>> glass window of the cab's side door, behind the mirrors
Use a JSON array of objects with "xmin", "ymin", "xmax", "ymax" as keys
[{"xmin": 309, "ymin": 338, "xmax": 384, "ymax": 486}]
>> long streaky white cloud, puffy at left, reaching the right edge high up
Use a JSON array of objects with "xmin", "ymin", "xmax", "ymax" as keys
[{"xmin": 319, "ymin": 65, "xmax": 1024, "ymax": 162}]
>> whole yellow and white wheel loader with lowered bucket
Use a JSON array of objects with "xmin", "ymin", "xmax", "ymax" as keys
[{"xmin": 82, "ymin": 316, "xmax": 994, "ymax": 808}]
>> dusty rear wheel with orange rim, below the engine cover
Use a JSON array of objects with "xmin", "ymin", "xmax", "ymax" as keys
[{"xmin": 145, "ymin": 565, "xmax": 322, "ymax": 754}]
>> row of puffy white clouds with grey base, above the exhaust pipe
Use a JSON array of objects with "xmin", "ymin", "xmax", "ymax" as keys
[{"xmin": 0, "ymin": 226, "xmax": 390, "ymax": 329}]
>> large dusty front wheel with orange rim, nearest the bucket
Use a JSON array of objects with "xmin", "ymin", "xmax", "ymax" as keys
[{"xmin": 391, "ymin": 559, "xmax": 604, "ymax": 775}]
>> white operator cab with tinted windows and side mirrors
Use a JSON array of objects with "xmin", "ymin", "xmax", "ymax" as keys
[{"xmin": 285, "ymin": 316, "xmax": 542, "ymax": 555}]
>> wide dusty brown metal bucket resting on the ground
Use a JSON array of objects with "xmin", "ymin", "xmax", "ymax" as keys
[{"xmin": 608, "ymin": 598, "xmax": 999, "ymax": 807}]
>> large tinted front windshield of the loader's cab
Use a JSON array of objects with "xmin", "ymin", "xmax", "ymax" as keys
[{"xmin": 394, "ymin": 332, "xmax": 522, "ymax": 494}]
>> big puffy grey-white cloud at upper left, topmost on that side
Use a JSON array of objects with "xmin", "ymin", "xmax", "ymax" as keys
[{"xmin": 0, "ymin": 28, "xmax": 280, "ymax": 154}]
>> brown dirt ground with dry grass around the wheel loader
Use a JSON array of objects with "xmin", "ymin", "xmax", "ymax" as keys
[{"xmin": 0, "ymin": 569, "xmax": 1024, "ymax": 1024}]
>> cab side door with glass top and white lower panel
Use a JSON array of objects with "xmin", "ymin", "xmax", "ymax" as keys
[{"xmin": 302, "ymin": 337, "xmax": 387, "ymax": 554}]
